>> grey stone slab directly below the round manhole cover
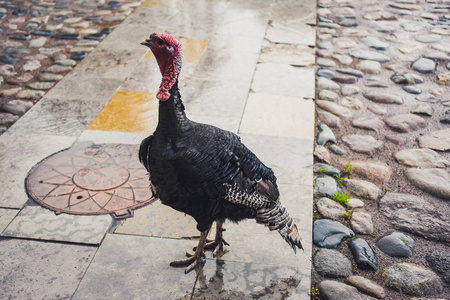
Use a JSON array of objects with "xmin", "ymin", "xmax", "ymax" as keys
[{"xmin": 2, "ymin": 206, "xmax": 112, "ymax": 244}]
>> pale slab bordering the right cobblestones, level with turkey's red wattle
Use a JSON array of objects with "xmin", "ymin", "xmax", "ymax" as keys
[{"xmin": 251, "ymin": 63, "xmax": 315, "ymax": 98}]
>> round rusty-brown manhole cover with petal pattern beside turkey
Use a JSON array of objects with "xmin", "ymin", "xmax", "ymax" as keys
[{"xmin": 26, "ymin": 143, "xmax": 155, "ymax": 219}]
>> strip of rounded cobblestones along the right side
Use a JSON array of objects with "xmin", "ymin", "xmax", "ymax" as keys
[{"xmin": 312, "ymin": 0, "xmax": 450, "ymax": 299}]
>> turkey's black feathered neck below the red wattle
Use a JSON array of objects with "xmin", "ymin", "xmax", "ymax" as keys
[{"xmin": 155, "ymin": 79, "xmax": 190, "ymax": 136}]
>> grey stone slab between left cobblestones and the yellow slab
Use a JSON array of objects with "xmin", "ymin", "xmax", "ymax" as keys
[{"xmin": 10, "ymin": 98, "xmax": 103, "ymax": 136}]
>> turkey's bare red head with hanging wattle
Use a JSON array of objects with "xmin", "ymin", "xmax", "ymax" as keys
[{"xmin": 141, "ymin": 32, "xmax": 181, "ymax": 101}]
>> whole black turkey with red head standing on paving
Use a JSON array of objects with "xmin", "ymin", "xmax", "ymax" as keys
[{"xmin": 139, "ymin": 33, "xmax": 302, "ymax": 273}]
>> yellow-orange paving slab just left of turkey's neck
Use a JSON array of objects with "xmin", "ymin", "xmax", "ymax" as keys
[{"xmin": 88, "ymin": 91, "xmax": 158, "ymax": 133}]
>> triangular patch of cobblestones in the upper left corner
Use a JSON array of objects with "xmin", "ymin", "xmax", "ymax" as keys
[{"xmin": 0, "ymin": 0, "xmax": 141, "ymax": 134}]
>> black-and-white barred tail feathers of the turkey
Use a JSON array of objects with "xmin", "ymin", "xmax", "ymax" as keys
[{"xmin": 256, "ymin": 201, "xmax": 303, "ymax": 253}]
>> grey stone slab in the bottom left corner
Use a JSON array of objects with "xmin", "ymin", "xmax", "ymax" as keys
[{"xmin": 0, "ymin": 238, "xmax": 97, "ymax": 299}]
